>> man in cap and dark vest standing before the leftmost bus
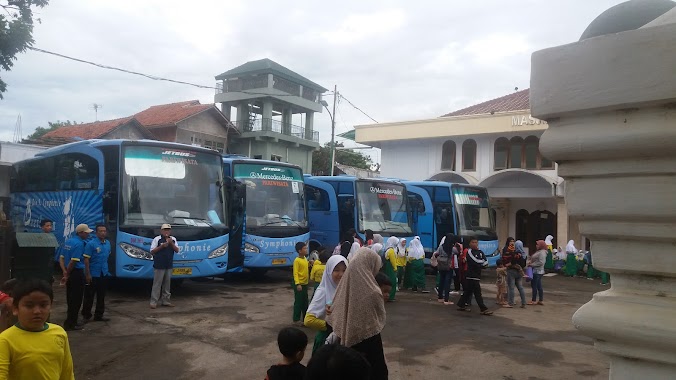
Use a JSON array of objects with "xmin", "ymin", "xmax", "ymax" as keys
[{"xmin": 150, "ymin": 224, "xmax": 178, "ymax": 309}]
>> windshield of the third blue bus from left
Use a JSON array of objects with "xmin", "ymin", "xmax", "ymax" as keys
[{"xmin": 357, "ymin": 181, "xmax": 412, "ymax": 236}]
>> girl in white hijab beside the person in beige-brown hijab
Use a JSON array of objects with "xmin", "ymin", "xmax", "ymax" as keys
[{"xmin": 303, "ymin": 255, "xmax": 347, "ymax": 353}]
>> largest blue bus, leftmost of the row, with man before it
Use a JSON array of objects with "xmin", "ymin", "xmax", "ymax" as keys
[{"xmin": 10, "ymin": 140, "xmax": 241, "ymax": 279}]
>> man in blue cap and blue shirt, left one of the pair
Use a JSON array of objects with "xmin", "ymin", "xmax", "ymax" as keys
[{"xmin": 61, "ymin": 224, "xmax": 92, "ymax": 330}]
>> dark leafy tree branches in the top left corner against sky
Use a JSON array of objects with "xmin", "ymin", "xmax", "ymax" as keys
[{"xmin": 0, "ymin": 0, "xmax": 49, "ymax": 99}]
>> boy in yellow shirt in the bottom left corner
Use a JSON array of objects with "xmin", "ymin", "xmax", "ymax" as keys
[{"xmin": 0, "ymin": 279, "xmax": 75, "ymax": 380}]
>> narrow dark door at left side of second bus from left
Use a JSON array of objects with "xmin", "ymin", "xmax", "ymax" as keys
[{"xmin": 226, "ymin": 178, "xmax": 246, "ymax": 270}]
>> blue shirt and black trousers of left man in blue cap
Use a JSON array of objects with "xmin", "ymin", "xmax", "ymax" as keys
[{"xmin": 61, "ymin": 236, "xmax": 87, "ymax": 329}]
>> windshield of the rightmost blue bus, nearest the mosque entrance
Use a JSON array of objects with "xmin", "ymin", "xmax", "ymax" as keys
[{"xmin": 452, "ymin": 186, "xmax": 497, "ymax": 240}]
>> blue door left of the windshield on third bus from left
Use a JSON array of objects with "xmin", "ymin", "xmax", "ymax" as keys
[{"xmin": 305, "ymin": 180, "xmax": 340, "ymax": 249}]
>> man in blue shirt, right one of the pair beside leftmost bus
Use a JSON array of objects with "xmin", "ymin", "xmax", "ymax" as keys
[{"xmin": 82, "ymin": 224, "xmax": 110, "ymax": 322}]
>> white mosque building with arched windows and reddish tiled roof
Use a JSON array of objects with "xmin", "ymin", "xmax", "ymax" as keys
[{"xmin": 355, "ymin": 89, "xmax": 585, "ymax": 255}]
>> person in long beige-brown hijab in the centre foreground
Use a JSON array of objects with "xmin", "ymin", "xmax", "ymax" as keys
[{"xmin": 327, "ymin": 249, "xmax": 394, "ymax": 380}]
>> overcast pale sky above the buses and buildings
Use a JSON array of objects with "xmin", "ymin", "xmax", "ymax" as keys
[{"xmin": 0, "ymin": 0, "xmax": 622, "ymax": 162}]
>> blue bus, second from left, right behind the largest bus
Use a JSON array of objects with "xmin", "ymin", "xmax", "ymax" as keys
[{"xmin": 223, "ymin": 155, "xmax": 310, "ymax": 274}]
